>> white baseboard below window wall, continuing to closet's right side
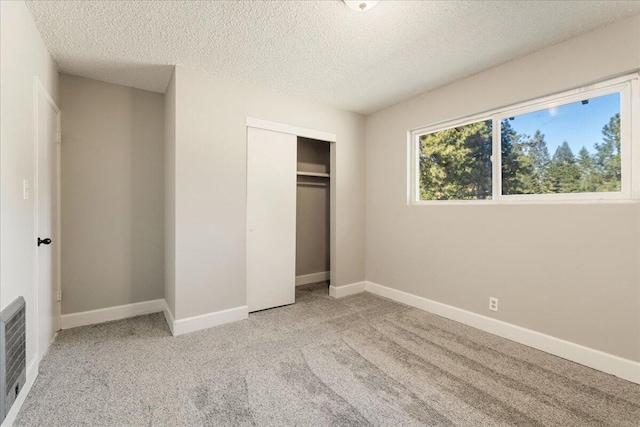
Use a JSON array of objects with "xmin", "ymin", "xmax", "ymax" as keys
[{"xmin": 329, "ymin": 282, "xmax": 640, "ymax": 384}]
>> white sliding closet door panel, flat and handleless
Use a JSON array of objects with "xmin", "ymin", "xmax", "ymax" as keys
[{"xmin": 247, "ymin": 127, "xmax": 297, "ymax": 311}]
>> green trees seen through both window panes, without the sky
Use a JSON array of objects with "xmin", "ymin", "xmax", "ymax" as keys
[{"xmin": 419, "ymin": 114, "xmax": 622, "ymax": 200}]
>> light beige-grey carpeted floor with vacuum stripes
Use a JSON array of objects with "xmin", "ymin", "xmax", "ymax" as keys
[{"xmin": 16, "ymin": 283, "xmax": 640, "ymax": 427}]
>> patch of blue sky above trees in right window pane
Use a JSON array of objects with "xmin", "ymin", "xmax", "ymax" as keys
[{"xmin": 504, "ymin": 93, "xmax": 620, "ymax": 157}]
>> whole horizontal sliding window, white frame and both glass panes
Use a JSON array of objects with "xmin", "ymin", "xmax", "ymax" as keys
[{"xmin": 409, "ymin": 74, "xmax": 640, "ymax": 204}]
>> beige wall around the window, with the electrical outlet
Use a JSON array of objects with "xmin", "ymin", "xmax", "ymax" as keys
[{"xmin": 366, "ymin": 16, "xmax": 640, "ymax": 361}]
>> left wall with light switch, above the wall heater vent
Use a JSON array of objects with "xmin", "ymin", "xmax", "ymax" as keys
[{"xmin": 0, "ymin": 1, "xmax": 60, "ymax": 372}]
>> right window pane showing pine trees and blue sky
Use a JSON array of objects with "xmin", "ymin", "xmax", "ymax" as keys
[{"xmin": 501, "ymin": 93, "xmax": 622, "ymax": 195}]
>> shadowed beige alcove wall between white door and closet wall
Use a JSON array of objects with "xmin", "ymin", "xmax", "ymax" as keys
[{"xmin": 60, "ymin": 75, "xmax": 164, "ymax": 314}]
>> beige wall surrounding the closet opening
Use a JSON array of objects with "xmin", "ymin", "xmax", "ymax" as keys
[{"xmin": 174, "ymin": 66, "xmax": 365, "ymax": 319}]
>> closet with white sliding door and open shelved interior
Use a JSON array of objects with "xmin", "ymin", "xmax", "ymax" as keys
[{"xmin": 247, "ymin": 126, "xmax": 335, "ymax": 312}]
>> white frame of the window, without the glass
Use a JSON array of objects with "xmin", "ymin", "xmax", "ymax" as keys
[{"xmin": 407, "ymin": 73, "xmax": 640, "ymax": 205}]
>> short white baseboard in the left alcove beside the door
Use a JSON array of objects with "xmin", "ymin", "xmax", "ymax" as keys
[{"xmin": 60, "ymin": 299, "xmax": 165, "ymax": 329}]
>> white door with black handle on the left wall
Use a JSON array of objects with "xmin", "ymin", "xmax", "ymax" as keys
[{"xmin": 34, "ymin": 81, "xmax": 60, "ymax": 358}]
